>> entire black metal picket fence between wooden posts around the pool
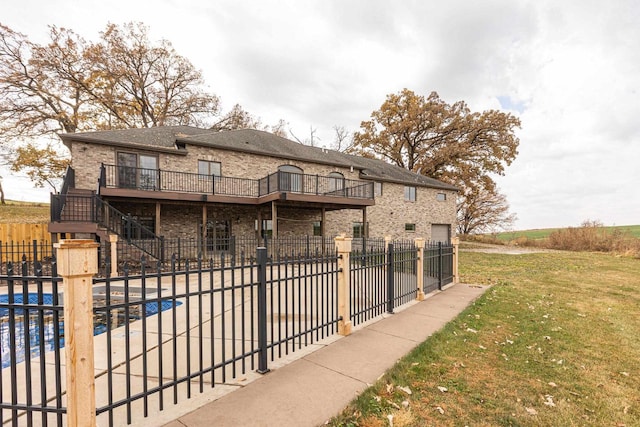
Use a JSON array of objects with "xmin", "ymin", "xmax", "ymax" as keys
[{"xmin": 0, "ymin": 238, "xmax": 453, "ymax": 426}]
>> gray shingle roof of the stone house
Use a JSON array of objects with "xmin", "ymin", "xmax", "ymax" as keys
[{"xmin": 60, "ymin": 126, "xmax": 457, "ymax": 190}]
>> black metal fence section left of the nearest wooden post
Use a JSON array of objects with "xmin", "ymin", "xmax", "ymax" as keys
[{"xmin": 0, "ymin": 260, "xmax": 66, "ymax": 426}]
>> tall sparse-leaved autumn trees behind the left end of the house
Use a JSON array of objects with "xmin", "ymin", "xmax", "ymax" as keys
[{"xmin": 0, "ymin": 23, "xmax": 282, "ymax": 185}]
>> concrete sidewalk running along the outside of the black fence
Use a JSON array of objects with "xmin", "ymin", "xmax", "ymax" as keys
[{"xmin": 165, "ymin": 284, "xmax": 488, "ymax": 427}]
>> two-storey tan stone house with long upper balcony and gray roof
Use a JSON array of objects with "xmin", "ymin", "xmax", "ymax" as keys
[{"xmin": 49, "ymin": 126, "xmax": 457, "ymax": 254}]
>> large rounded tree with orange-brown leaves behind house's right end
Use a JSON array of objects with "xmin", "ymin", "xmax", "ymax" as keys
[{"xmin": 348, "ymin": 89, "xmax": 520, "ymax": 232}]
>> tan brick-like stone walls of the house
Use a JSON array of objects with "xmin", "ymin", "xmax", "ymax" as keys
[{"xmin": 65, "ymin": 134, "xmax": 456, "ymax": 240}]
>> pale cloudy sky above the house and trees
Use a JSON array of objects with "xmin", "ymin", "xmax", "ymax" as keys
[{"xmin": 0, "ymin": 0, "xmax": 640, "ymax": 229}]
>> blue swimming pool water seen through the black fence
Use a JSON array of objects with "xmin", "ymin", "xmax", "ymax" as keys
[{"xmin": 0, "ymin": 293, "xmax": 182, "ymax": 369}]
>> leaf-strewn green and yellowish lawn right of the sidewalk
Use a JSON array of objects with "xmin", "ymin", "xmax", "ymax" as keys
[{"xmin": 329, "ymin": 252, "xmax": 640, "ymax": 427}]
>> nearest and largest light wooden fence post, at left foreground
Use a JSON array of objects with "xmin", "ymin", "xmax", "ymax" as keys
[{"xmin": 55, "ymin": 239, "xmax": 100, "ymax": 427}]
